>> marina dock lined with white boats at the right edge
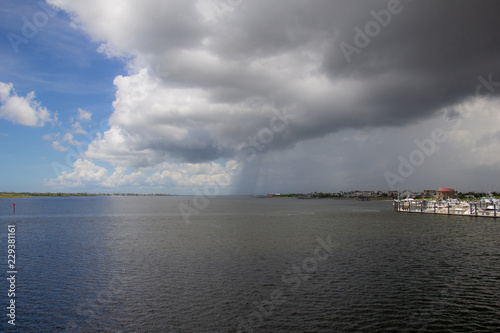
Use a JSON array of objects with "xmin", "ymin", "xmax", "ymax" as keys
[{"xmin": 394, "ymin": 198, "xmax": 500, "ymax": 218}]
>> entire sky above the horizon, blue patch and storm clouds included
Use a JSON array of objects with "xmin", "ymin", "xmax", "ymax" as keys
[{"xmin": 0, "ymin": 0, "xmax": 500, "ymax": 195}]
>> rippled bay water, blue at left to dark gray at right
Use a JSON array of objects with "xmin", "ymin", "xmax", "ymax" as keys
[{"xmin": 0, "ymin": 197, "xmax": 500, "ymax": 332}]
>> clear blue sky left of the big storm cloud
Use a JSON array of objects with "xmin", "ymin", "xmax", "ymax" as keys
[{"xmin": 0, "ymin": 1, "xmax": 126, "ymax": 191}]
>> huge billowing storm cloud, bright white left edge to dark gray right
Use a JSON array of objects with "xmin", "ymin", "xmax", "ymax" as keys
[{"xmin": 51, "ymin": 0, "xmax": 500, "ymax": 191}]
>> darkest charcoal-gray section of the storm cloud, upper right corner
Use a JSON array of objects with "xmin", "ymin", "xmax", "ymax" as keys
[{"xmin": 323, "ymin": 1, "xmax": 500, "ymax": 118}]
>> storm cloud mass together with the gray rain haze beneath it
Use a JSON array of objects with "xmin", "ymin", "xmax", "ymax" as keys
[{"xmin": 44, "ymin": 0, "xmax": 500, "ymax": 192}]
